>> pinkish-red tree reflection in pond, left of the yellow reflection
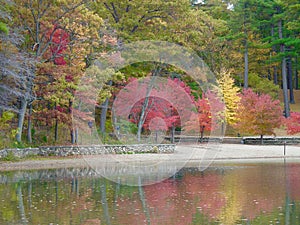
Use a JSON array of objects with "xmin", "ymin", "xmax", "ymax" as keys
[{"xmin": 130, "ymin": 171, "xmax": 225, "ymax": 225}]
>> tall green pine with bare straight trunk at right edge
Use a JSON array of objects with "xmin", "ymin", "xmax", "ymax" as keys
[{"xmin": 255, "ymin": 0, "xmax": 299, "ymax": 117}]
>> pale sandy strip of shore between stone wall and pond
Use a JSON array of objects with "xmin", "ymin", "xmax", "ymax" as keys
[{"xmin": 0, "ymin": 144, "xmax": 300, "ymax": 171}]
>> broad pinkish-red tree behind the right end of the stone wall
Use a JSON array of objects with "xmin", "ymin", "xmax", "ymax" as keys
[{"xmin": 113, "ymin": 77, "xmax": 194, "ymax": 142}]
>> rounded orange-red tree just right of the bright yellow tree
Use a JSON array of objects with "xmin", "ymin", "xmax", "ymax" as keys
[{"xmin": 235, "ymin": 88, "xmax": 282, "ymax": 143}]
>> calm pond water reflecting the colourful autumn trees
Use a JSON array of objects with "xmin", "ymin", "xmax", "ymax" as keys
[{"xmin": 0, "ymin": 163, "xmax": 300, "ymax": 225}]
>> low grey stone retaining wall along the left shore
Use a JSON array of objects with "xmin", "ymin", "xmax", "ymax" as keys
[{"xmin": 0, "ymin": 144, "xmax": 175, "ymax": 158}]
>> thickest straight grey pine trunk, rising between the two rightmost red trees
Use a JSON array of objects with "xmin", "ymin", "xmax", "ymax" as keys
[{"xmin": 278, "ymin": 20, "xmax": 290, "ymax": 118}]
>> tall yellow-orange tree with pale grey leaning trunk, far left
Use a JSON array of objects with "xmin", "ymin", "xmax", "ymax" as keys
[{"xmin": 7, "ymin": 0, "xmax": 86, "ymax": 142}]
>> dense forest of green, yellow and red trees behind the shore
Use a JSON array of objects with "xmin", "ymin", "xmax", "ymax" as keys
[{"xmin": 0, "ymin": 0, "xmax": 300, "ymax": 148}]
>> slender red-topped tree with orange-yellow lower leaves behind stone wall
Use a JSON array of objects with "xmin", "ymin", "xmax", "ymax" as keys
[{"xmin": 35, "ymin": 25, "xmax": 78, "ymax": 141}]
